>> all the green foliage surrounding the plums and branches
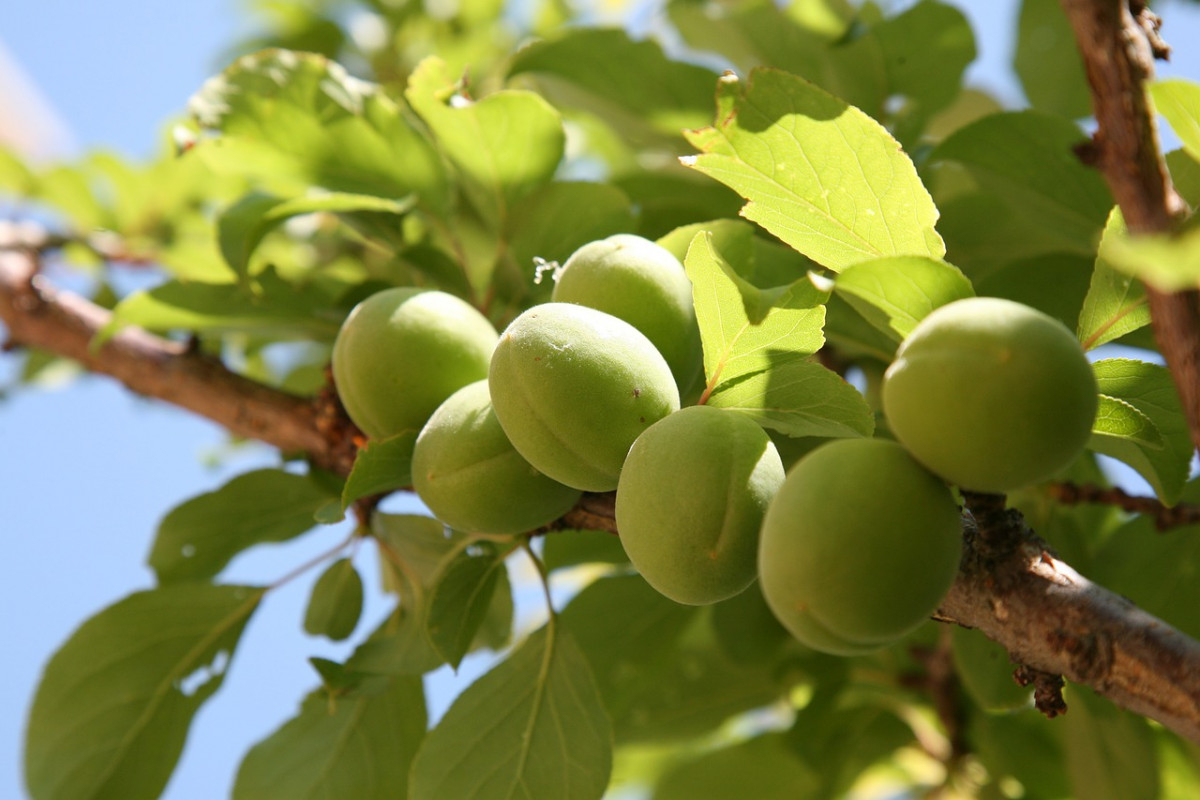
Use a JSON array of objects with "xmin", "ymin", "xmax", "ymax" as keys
[{"xmin": 7, "ymin": 0, "xmax": 1200, "ymax": 800}]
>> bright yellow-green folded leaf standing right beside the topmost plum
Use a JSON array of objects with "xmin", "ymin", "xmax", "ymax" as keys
[{"xmin": 684, "ymin": 233, "xmax": 828, "ymax": 390}]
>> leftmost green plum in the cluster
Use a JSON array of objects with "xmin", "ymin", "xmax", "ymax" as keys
[{"xmin": 332, "ymin": 287, "xmax": 498, "ymax": 439}]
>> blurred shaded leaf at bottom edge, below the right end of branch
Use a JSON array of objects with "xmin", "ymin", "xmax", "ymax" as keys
[{"xmin": 1063, "ymin": 686, "xmax": 1159, "ymax": 800}]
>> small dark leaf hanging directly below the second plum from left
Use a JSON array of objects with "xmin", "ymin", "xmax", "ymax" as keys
[{"xmin": 426, "ymin": 541, "xmax": 505, "ymax": 669}]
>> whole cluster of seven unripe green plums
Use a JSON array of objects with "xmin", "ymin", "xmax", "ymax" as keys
[{"xmin": 334, "ymin": 235, "xmax": 1097, "ymax": 655}]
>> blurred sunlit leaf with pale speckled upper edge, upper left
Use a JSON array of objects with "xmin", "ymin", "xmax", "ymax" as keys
[{"xmin": 188, "ymin": 49, "xmax": 449, "ymax": 207}]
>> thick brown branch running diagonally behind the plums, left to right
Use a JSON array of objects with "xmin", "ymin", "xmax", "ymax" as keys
[{"xmin": 7, "ymin": 251, "xmax": 1200, "ymax": 741}]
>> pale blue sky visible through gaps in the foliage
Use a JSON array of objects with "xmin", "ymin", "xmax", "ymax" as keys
[{"xmin": 0, "ymin": 0, "xmax": 1200, "ymax": 800}]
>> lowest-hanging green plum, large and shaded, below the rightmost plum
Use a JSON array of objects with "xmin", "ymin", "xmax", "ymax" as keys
[{"xmin": 758, "ymin": 439, "xmax": 962, "ymax": 655}]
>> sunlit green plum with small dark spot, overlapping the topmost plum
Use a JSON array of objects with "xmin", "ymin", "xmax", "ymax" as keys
[{"xmin": 487, "ymin": 302, "xmax": 679, "ymax": 492}]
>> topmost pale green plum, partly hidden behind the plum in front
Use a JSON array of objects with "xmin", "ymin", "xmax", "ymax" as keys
[{"xmin": 551, "ymin": 234, "xmax": 703, "ymax": 390}]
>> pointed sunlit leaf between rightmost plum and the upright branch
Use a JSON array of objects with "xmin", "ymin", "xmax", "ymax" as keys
[{"xmin": 1078, "ymin": 209, "xmax": 1150, "ymax": 350}]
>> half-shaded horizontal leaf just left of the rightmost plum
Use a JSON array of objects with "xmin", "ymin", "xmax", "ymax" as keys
[{"xmin": 708, "ymin": 361, "xmax": 875, "ymax": 437}]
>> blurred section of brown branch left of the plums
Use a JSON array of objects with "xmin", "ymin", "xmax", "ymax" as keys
[{"xmin": 0, "ymin": 249, "xmax": 355, "ymax": 475}]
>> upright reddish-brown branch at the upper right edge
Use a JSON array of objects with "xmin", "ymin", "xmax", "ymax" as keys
[{"xmin": 1062, "ymin": 0, "xmax": 1200, "ymax": 447}]
